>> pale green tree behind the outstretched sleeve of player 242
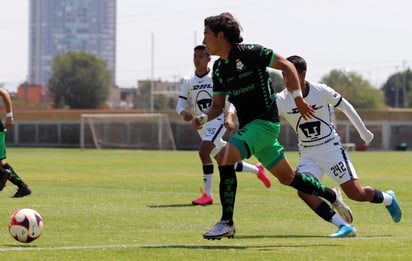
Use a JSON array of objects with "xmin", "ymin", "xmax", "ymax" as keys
[{"xmin": 321, "ymin": 70, "xmax": 385, "ymax": 109}]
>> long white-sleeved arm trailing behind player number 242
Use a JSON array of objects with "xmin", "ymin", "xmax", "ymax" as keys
[{"xmin": 336, "ymin": 97, "xmax": 373, "ymax": 144}]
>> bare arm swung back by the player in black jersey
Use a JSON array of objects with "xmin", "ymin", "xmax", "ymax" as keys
[{"xmin": 271, "ymin": 54, "xmax": 315, "ymax": 119}]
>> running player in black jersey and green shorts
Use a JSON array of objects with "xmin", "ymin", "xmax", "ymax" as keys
[{"xmin": 192, "ymin": 13, "xmax": 352, "ymax": 239}]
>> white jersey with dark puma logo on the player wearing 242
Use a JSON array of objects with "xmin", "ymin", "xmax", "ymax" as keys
[{"xmin": 276, "ymin": 82, "xmax": 342, "ymax": 150}]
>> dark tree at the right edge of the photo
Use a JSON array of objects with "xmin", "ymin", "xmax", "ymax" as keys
[{"xmin": 382, "ymin": 69, "xmax": 412, "ymax": 108}]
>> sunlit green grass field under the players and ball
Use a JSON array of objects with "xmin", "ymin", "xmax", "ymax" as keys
[{"xmin": 0, "ymin": 148, "xmax": 412, "ymax": 260}]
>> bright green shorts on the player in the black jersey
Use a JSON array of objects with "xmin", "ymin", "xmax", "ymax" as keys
[{"xmin": 229, "ymin": 119, "xmax": 285, "ymax": 169}]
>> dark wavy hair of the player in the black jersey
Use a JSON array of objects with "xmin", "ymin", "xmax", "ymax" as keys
[{"xmin": 205, "ymin": 12, "xmax": 243, "ymax": 44}]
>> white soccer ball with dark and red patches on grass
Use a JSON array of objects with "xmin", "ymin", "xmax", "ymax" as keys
[{"xmin": 9, "ymin": 208, "xmax": 43, "ymax": 243}]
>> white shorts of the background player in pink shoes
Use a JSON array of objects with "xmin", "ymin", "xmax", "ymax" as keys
[{"xmin": 197, "ymin": 113, "xmax": 226, "ymax": 157}]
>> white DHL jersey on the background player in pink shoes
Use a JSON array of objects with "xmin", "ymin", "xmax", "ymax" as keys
[{"xmin": 176, "ymin": 70, "xmax": 213, "ymax": 115}]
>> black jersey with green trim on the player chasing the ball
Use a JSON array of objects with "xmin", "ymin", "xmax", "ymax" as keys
[{"xmin": 213, "ymin": 44, "xmax": 279, "ymax": 127}]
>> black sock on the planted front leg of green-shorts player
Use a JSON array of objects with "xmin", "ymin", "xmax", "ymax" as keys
[{"xmin": 219, "ymin": 165, "xmax": 237, "ymax": 223}]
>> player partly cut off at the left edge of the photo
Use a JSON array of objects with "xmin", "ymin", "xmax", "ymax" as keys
[{"xmin": 0, "ymin": 88, "xmax": 31, "ymax": 198}]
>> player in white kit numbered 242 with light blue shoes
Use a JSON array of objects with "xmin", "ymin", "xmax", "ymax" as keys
[{"xmin": 276, "ymin": 55, "xmax": 402, "ymax": 237}]
